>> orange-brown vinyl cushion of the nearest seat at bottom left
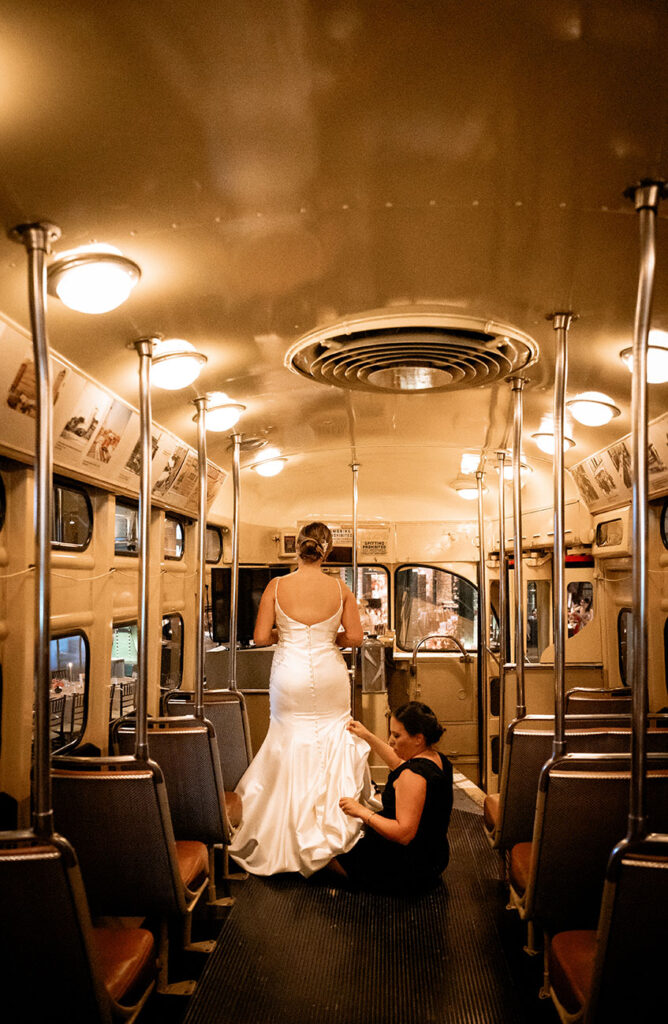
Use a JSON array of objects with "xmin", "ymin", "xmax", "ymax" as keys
[{"xmin": 93, "ymin": 928, "xmax": 157, "ymax": 1005}]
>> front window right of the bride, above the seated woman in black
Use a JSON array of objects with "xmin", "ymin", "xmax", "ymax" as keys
[{"xmin": 394, "ymin": 565, "xmax": 477, "ymax": 650}]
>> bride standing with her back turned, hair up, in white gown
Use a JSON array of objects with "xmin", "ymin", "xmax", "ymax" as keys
[{"xmin": 229, "ymin": 522, "xmax": 370, "ymax": 876}]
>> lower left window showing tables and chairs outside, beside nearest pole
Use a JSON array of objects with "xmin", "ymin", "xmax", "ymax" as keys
[{"xmin": 49, "ymin": 631, "xmax": 89, "ymax": 751}]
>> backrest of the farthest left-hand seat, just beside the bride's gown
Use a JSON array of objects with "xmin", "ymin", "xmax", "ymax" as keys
[{"xmin": 165, "ymin": 690, "xmax": 253, "ymax": 790}]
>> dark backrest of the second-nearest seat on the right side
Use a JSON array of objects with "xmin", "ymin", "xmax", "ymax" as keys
[{"xmin": 526, "ymin": 754, "xmax": 668, "ymax": 933}]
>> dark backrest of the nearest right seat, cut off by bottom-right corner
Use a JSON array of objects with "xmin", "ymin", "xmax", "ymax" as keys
[{"xmin": 585, "ymin": 836, "xmax": 668, "ymax": 1024}]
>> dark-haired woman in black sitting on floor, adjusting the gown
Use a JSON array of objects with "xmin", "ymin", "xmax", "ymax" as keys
[{"xmin": 328, "ymin": 700, "xmax": 453, "ymax": 893}]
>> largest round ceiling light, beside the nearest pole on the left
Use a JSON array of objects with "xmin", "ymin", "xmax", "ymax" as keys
[{"xmin": 46, "ymin": 244, "xmax": 141, "ymax": 313}]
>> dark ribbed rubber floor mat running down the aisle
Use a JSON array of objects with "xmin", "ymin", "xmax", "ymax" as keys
[{"xmin": 184, "ymin": 810, "xmax": 556, "ymax": 1024}]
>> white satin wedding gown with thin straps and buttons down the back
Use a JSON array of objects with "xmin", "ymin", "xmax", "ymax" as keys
[{"xmin": 229, "ymin": 587, "xmax": 371, "ymax": 876}]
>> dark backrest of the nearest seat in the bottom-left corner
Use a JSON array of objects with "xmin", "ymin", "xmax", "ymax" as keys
[{"xmin": 0, "ymin": 833, "xmax": 112, "ymax": 1024}]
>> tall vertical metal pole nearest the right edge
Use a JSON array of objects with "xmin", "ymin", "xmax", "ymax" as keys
[{"xmin": 626, "ymin": 181, "xmax": 668, "ymax": 840}]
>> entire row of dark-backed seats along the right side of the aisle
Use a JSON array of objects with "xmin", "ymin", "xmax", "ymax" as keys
[{"xmin": 484, "ymin": 693, "xmax": 668, "ymax": 1024}]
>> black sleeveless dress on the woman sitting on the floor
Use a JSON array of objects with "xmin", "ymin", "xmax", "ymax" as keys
[{"xmin": 336, "ymin": 754, "xmax": 453, "ymax": 894}]
